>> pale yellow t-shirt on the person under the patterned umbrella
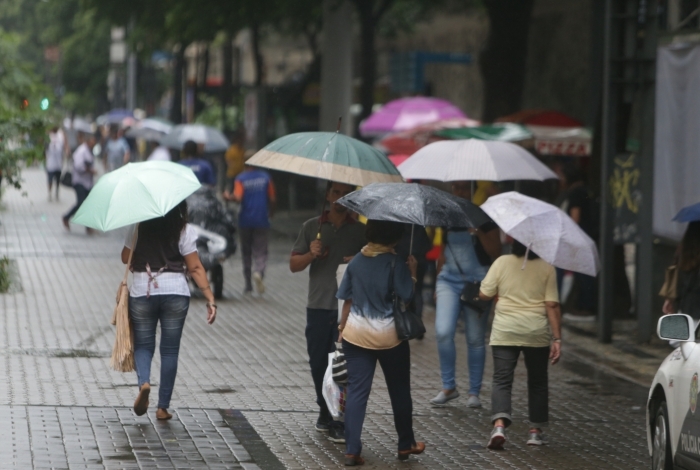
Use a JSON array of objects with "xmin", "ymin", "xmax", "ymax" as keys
[{"xmin": 481, "ymin": 255, "xmax": 559, "ymax": 347}]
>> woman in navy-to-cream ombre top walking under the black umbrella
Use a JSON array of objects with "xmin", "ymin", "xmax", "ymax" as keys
[{"xmin": 337, "ymin": 220, "xmax": 425, "ymax": 466}]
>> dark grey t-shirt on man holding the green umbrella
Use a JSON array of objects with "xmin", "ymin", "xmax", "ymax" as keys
[{"xmin": 292, "ymin": 214, "xmax": 366, "ymax": 310}]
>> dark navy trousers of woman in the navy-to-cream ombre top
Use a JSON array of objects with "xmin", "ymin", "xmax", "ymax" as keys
[{"xmin": 343, "ymin": 340, "xmax": 416, "ymax": 455}]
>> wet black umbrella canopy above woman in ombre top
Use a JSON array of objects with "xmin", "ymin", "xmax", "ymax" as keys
[{"xmin": 338, "ymin": 183, "xmax": 489, "ymax": 227}]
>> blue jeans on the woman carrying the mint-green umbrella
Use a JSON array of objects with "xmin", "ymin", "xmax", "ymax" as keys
[{"xmin": 129, "ymin": 295, "xmax": 190, "ymax": 409}]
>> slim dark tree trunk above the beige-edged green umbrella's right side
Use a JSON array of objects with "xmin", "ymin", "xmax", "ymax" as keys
[{"xmin": 355, "ymin": 0, "xmax": 377, "ymax": 135}]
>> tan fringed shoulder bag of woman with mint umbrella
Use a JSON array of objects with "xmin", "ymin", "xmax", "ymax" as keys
[{"xmin": 109, "ymin": 225, "xmax": 138, "ymax": 372}]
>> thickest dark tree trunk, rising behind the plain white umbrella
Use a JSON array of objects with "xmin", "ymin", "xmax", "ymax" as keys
[{"xmin": 479, "ymin": 0, "xmax": 534, "ymax": 122}]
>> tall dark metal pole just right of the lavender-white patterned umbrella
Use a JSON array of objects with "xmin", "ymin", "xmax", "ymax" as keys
[{"xmin": 598, "ymin": 0, "xmax": 617, "ymax": 343}]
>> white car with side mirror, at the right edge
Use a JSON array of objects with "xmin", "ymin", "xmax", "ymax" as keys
[{"xmin": 647, "ymin": 314, "xmax": 700, "ymax": 470}]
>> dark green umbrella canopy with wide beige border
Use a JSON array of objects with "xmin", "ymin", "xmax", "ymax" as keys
[{"xmin": 246, "ymin": 132, "xmax": 403, "ymax": 186}]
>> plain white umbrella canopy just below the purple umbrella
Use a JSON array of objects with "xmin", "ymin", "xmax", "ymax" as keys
[{"xmin": 398, "ymin": 139, "xmax": 558, "ymax": 181}]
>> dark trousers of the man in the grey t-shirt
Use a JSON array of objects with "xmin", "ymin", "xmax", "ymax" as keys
[{"xmin": 306, "ymin": 308, "xmax": 338, "ymax": 417}]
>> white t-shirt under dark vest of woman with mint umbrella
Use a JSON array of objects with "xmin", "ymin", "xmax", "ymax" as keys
[{"xmin": 124, "ymin": 224, "xmax": 197, "ymax": 297}]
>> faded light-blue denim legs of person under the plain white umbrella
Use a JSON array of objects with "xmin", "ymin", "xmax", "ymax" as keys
[{"xmin": 435, "ymin": 279, "xmax": 489, "ymax": 396}]
